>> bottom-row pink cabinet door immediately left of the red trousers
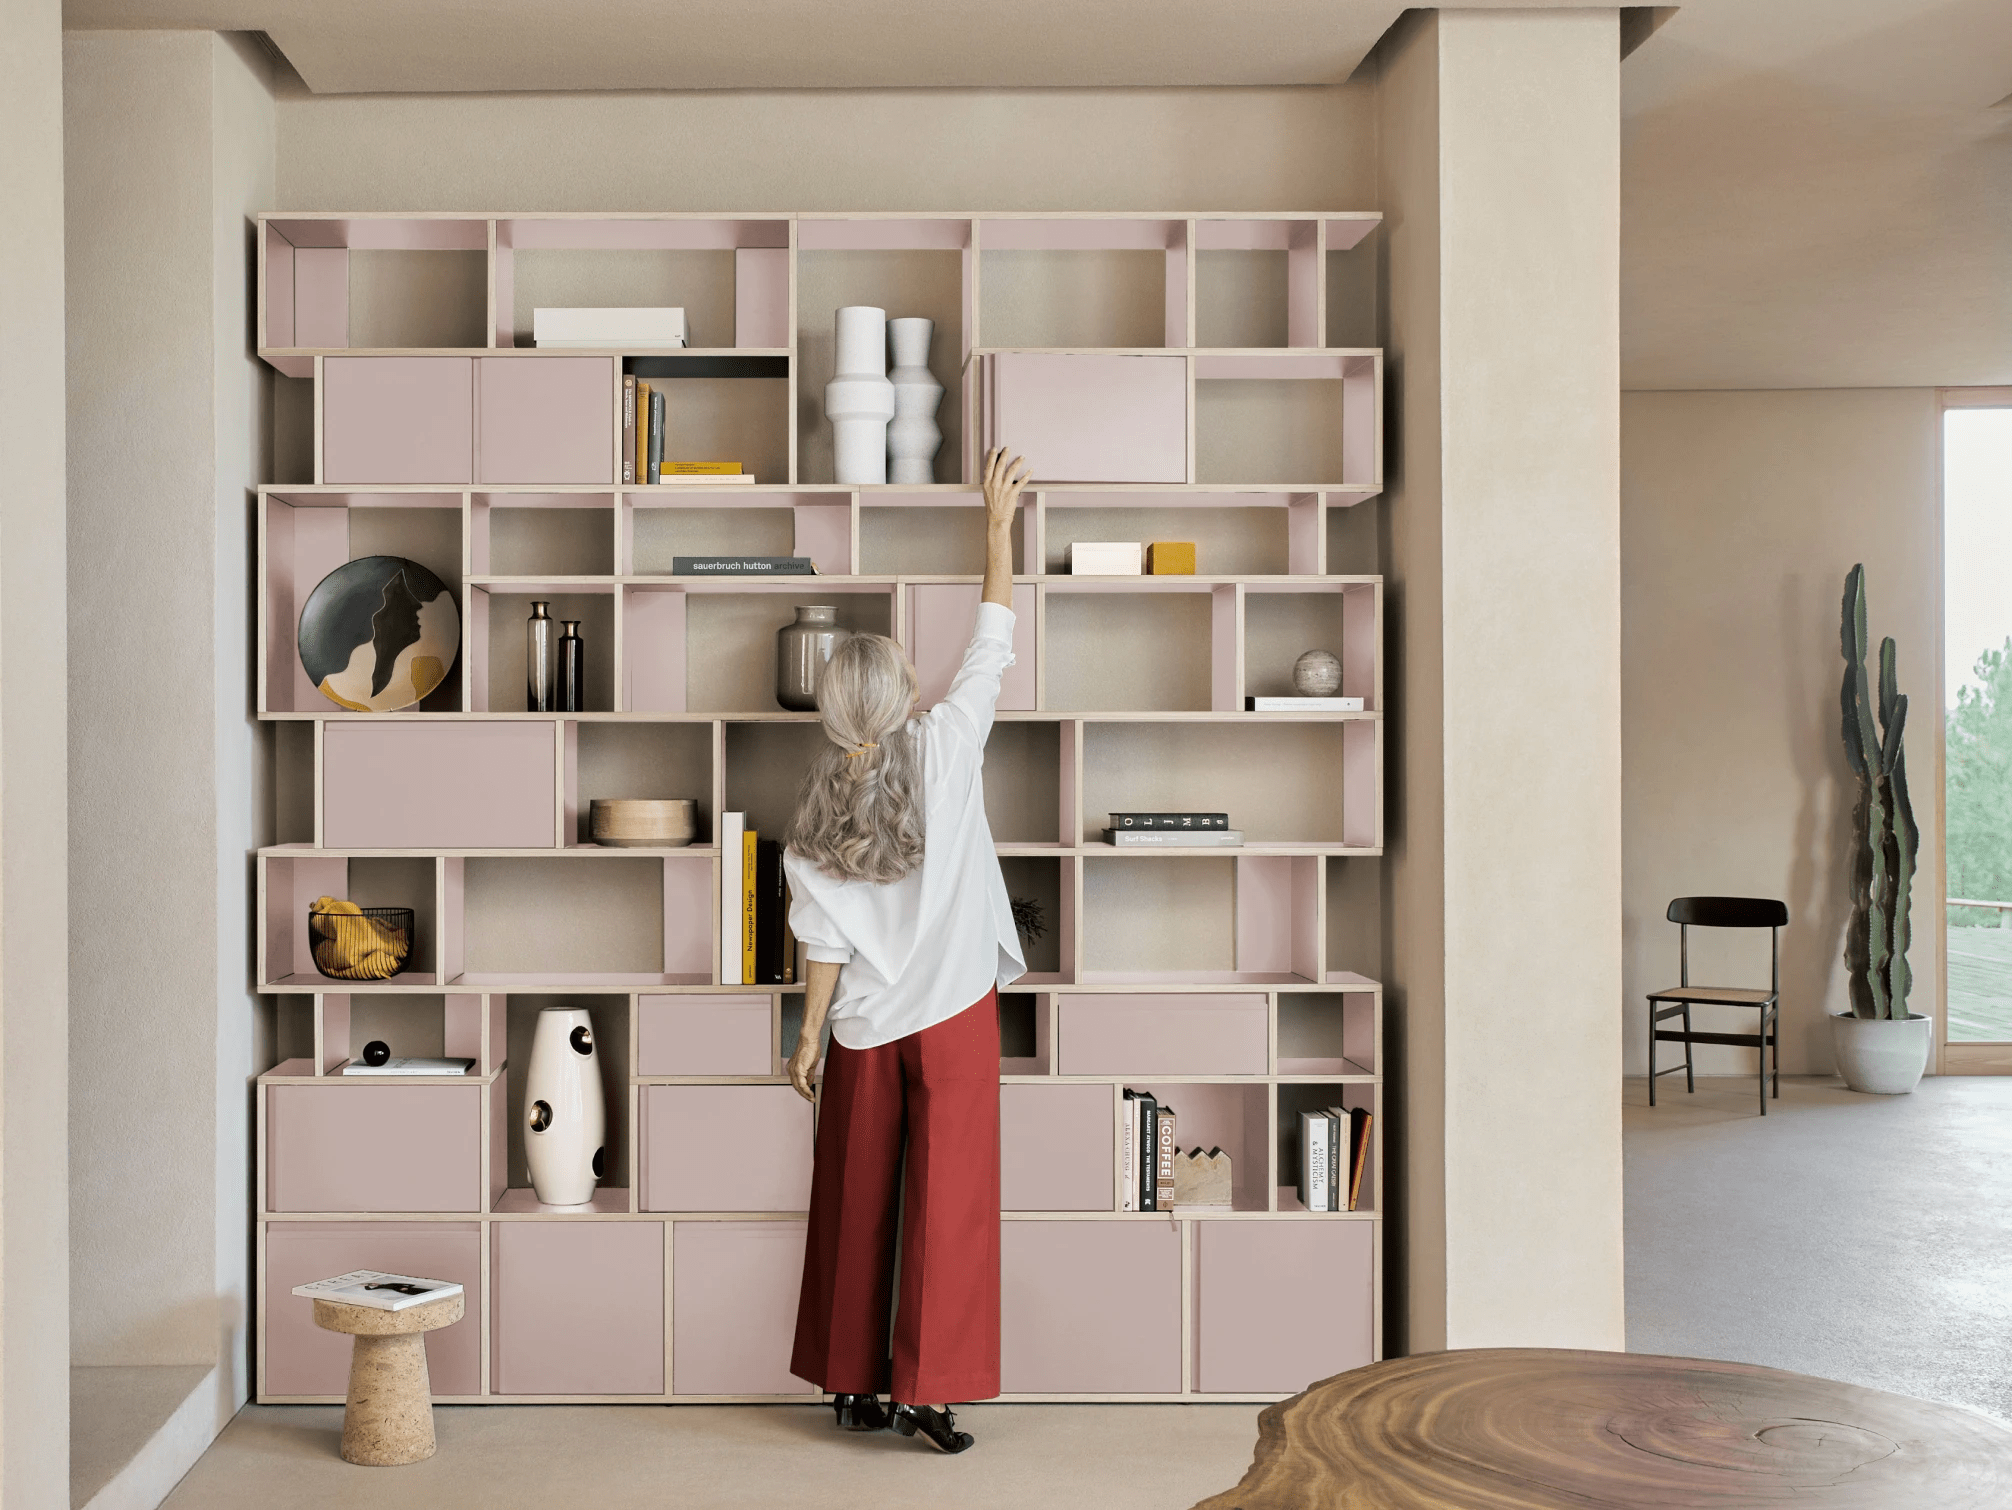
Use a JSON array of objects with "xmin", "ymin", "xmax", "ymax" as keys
[{"xmin": 670, "ymin": 1222, "xmax": 817, "ymax": 1395}]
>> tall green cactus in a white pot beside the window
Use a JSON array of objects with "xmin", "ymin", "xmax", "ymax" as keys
[{"xmin": 1831, "ymin": 564, "xmax": 1932, "ymax": 1095}]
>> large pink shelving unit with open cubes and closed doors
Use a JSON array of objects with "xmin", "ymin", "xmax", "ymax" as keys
[{"xmin": 254, "ymin": 211, "xmax": 1386, "ymax": 1403}]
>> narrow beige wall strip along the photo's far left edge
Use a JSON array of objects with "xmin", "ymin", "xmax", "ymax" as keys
[{"xmin": 0, "ymin": 0, "xmax": 70, "ymax": 1510}]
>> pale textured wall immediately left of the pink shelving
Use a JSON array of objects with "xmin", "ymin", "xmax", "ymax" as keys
[{"xmin": 64, "ymin": 32, "xmax": 274, "ymax": 1417}]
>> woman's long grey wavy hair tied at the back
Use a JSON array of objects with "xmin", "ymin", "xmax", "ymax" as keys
[{"xmin": 789, "ymin": 634, "xmax": 921, "ymax": 882}]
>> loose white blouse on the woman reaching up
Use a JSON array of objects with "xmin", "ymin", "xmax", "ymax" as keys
[{"xmin": 783, "ymin": 602, "xmax": 1026, "ymax": 1049}]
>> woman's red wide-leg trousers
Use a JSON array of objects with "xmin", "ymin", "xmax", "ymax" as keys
[{"xmin": 789, "ymin": 991, "xmax": 1000, "ymax": 1405}]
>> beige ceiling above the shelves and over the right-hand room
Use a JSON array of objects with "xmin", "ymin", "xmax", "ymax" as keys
[{"xmin": 64, "ymin": 0, "xmax": 2012, "ymax": 389}]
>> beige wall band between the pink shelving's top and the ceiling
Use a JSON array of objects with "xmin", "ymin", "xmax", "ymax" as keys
[{"xmin": 280, "ymin": 87, "xmax": 1374, "ymax": 211}]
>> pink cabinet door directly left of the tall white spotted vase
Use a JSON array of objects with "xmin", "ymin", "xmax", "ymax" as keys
[{"xmin": 266, "ymin": 1083, "xmax": 483, "ymax": 1212}]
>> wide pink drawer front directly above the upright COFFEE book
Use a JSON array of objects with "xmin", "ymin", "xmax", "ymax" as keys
[{"xmin": 1060, "ymin": 995, "xmax": 1270, "ymax": 1075}]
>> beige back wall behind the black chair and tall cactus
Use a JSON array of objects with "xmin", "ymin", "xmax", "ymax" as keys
[{"xmin": 1622, "ymin": 389, "xmax": 1942, "ymax": 1091}]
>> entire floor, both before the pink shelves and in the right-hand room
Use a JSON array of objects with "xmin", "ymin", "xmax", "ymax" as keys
[{"xmin": 145, "ymin": 1079, "xmax": 2012, "ymax": 1510}]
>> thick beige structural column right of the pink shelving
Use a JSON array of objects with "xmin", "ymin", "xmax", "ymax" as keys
[{"xmin": 1378, "ymin": 10, "xmax": 1624, "ymax": 1351}]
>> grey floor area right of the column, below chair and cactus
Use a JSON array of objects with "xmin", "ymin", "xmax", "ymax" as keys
[{"xmin": 1626, "ymin": 1075, "xmax": 2012, "ymax": 1421}]
